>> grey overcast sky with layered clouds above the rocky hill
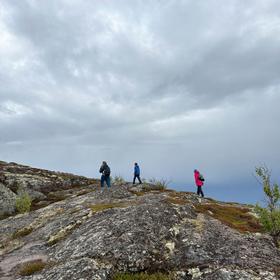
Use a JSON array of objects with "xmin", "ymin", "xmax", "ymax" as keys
[{"xmin": 0, "ymin": 0, "xmax": 280, "ymax": 205}]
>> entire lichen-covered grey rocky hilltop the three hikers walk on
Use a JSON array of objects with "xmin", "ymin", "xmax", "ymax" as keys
[{"xmin": 0, "ymin": 162, "xmax": 280, "ymax": 280}]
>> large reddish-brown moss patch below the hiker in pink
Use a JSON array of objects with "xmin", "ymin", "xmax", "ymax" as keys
[{"xmin": 195, "ymin": 203, "xmax": 263, "ymax": 232}]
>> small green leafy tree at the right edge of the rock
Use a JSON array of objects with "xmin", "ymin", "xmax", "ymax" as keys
[{"xmin": 255, "ymin": 166, "xmax": 280, "ymax": 247}]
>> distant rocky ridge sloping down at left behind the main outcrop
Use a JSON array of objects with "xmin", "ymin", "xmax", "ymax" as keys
[{"xmin": 0, "ymin": 161, "xmax": 94, "ymax": 218}]
